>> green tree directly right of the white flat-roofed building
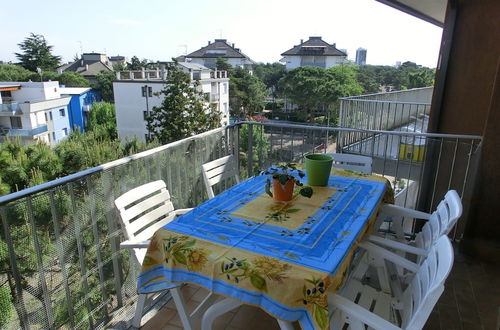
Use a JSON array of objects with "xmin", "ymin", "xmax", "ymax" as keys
[{"xmin": 229, "ymin": 67, "xmax": 266, "ymax": 118}]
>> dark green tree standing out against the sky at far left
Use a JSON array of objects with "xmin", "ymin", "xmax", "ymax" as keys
[{"xmin": 15, "ymin": 33, "xmax": 61, "ymax": 71}]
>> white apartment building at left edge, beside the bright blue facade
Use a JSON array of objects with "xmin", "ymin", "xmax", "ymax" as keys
[{"xmin": 0, "ymin": 81, "xmax": 71, "ymax": 145}]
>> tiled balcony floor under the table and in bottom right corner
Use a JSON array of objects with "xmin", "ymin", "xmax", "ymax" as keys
[{"xmin": 142, "ymin": 248, "xmax": 500, "ymax": 330}]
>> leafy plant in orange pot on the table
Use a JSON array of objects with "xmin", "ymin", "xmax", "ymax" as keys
[{"xmin": 262, "ymin": 163, "xmax": 313, "ymax": 201}]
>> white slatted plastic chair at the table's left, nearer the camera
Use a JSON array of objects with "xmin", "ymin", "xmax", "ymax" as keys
[{"xmin": 115, "ymin": 180, "xmax": 201, "ymax": 329}]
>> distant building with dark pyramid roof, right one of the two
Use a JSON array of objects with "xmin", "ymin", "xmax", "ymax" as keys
[{"xmin": 280, "ymin": 37, "xmax": 347, "ymax": 70}]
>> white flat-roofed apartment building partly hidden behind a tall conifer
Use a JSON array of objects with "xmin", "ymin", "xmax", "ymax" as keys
[{"xmin": 113, "ymin": 63, "xmax": 229, "ymax": 142}]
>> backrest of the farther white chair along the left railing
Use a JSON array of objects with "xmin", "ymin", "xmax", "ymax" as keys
[{"xmin": 202, "ymin": 155, "xmax": 240, "ymax": 198}]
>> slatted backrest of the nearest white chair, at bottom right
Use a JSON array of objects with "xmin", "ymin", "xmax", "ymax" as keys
[{"xmin": 401, "ymin": 236, "xmax": 453, "ymax": 330}]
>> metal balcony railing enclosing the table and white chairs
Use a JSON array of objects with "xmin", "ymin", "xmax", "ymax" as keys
[{"xmin": 0, "ymin": 122, "xmax": 493, "ymax": 329}]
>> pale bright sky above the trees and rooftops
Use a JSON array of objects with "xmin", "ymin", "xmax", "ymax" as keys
[{"xmin": 0, "ymin": 0, "xmax": 442, "ymax": 67}]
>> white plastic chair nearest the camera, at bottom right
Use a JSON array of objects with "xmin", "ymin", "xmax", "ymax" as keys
[{"xmin": 328, "ymin": 236, "xmax": 453, "ymax": 330}]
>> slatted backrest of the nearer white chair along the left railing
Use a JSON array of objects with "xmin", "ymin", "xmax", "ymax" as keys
[{"xmin": 115, "ymin": 180, "xmax": 175, "ymax": 261}]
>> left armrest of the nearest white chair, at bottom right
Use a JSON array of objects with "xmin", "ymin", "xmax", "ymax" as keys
[{"xmin": 328, "ymin": 294, "xmax": 401, "ymax": 330}]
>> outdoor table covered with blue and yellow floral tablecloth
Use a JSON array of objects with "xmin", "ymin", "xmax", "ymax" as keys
[{"xmin": 138, "ymin": 170, "xmax": 393, "ymax": 329}]
